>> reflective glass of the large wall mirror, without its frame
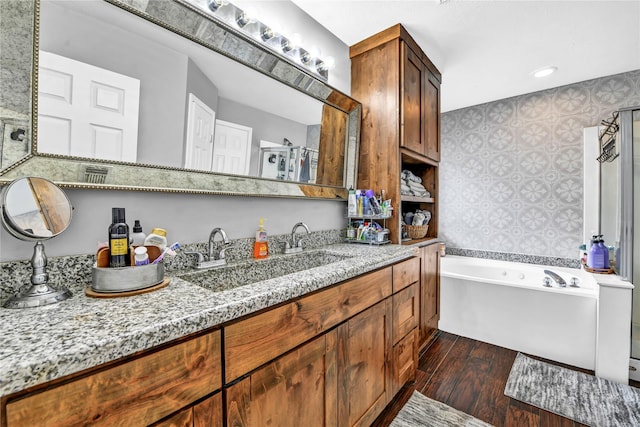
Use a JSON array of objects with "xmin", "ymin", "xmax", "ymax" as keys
[{"xmin": 37, "ymin": 0, "xmax": 348, "ymax": 187}]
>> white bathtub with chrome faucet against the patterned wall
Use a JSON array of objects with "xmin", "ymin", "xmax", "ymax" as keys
[{"xmin": 438, "ymin": 255, "xmax": 598, "ymax": 370}]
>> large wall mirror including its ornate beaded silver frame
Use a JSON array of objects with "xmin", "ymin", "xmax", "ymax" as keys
[{"xmin": 0, "ymin": 0, "xmax": 361, "ymax": 199}]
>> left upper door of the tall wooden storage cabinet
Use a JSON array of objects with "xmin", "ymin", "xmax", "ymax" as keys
[{"xmin": 400, "ymin": 43, "xmax": 425, "ymax": 154}]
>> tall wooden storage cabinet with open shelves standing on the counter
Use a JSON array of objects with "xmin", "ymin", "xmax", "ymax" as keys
[{"xmin": 350, "ymin": 24, "xmax": 441, "ymax": 243}]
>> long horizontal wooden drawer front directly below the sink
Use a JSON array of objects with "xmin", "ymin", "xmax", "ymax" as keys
[{"xmin": 224, "ymin": 267, "xmax": 392, "ymax": 383}]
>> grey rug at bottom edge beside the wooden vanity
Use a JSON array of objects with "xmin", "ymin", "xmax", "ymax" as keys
[{"xmin": 389, "ymin": 391, "xmax": 491, "ymax": 427}]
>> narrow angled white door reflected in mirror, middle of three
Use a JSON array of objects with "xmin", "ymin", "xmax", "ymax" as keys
[{"xmin": 184, "ymin": 93, "xmax": 216, "ymax": 171}]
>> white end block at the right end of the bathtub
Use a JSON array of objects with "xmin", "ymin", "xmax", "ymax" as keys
[{"xmin": 593, "ymin": 274, "xmax": 633, "ymax": 384}]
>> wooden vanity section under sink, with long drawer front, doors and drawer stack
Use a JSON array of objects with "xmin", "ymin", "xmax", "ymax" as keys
[{"xmin": 224, "ymin": 257, "xmax": 421, "ymax": 427}]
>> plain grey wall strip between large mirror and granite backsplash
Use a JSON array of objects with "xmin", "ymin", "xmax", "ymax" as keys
[{"xmin": 0, "ymin": 189, "xmax": 346, "ymax": 261}]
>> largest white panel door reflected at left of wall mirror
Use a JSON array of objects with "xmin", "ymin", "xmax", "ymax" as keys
[{"xmin": 38, "ymin": 51, "xmax": 140, "ymax": 162}]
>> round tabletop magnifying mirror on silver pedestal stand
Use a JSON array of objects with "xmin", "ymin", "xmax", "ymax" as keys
[{"xmin": 1, "ymin": 177, "xmax": 73, "ymax": 308}]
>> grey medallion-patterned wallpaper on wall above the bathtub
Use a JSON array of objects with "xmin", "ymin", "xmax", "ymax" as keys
[{"xmin": 439, "ymin": 70, "xmax": 640, "ymax": 258}]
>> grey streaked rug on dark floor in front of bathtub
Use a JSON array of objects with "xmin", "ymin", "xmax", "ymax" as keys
[{"xmin": 504, "ymin": 353, "xmax": 640, "ymax": 427}]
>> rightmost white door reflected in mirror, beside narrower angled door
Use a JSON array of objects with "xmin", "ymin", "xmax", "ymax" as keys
[{"xmin": 211, "ymin": 120, "xmax": 253, "ymax": 175}]
